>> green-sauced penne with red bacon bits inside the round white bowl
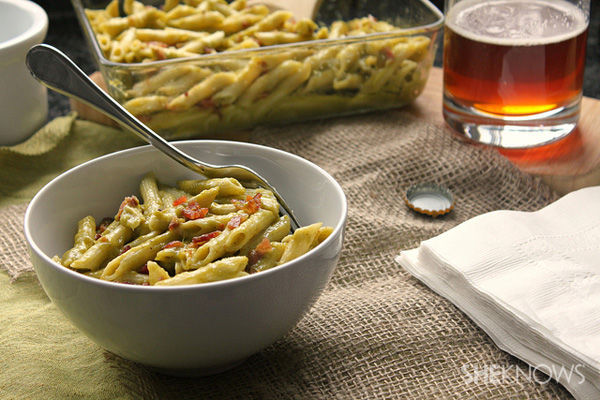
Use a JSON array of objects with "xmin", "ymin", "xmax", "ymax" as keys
[{"xmin": 54, "ymin": 172, "xmax": 332, "ymax": 286}]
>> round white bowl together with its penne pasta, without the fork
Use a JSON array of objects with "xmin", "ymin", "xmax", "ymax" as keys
[{"xmin": 24, "ymin": 140, "xmax": 347, "ymax": 376}]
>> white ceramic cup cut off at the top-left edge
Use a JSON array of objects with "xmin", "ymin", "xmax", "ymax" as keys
[{"xmin": 0, "ymin": 0, "xmax": 48, "ymax": 145}]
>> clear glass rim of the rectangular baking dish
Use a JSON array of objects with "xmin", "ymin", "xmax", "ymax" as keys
[{"xmin": 71, "ymin": 0, "xmax": 445, "ymax": 70}]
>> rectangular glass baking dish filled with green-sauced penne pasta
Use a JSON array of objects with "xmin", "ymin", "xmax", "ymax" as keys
[{"xmin": 72, "ymin": 0, "xmax": 444, "ymax": 139}]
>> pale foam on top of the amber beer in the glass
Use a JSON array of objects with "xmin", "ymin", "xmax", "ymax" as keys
[{"xmin": 446, "ymin": 0, "xmax": 588, "ymax": 46}]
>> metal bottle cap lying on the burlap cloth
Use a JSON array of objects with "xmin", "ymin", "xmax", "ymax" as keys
[{"xmin": 404, "ymin": 183, "xmax": 454, "ymax": 217}]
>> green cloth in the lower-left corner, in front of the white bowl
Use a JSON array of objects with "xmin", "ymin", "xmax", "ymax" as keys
[{"xmin": 0, "ymin": 271, "xmax": 149, "ymax": 399}]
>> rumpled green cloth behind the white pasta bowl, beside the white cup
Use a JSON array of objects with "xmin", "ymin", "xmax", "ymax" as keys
[{"xmin": 0, "ymin": 113, "xmax": 143, "ymax": 207}]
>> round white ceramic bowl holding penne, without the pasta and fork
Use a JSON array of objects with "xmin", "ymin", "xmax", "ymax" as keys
[{"xmin": 25, "ymin": 141, "xmax": 347, "ymax": 375}]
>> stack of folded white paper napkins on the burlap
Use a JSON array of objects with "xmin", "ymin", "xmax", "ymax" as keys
[{"xmin": 396, "ymin": 187, "xmax": 600, "ymax": 399}]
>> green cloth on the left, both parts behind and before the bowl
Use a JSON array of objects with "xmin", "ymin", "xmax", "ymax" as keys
[{"xmin": 0, "ymin": 113, "xmax": 152, "ymax": 399}]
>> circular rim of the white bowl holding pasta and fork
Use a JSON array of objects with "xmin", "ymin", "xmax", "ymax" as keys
[{"xmin": 23, "ymin": 139, "xmax": 348, "ymax": 292}]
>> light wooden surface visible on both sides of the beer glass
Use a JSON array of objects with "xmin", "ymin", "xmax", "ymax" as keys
[{"xmin": 408, "ymin": 68, "xmax": 600, "ymax": 194}]
